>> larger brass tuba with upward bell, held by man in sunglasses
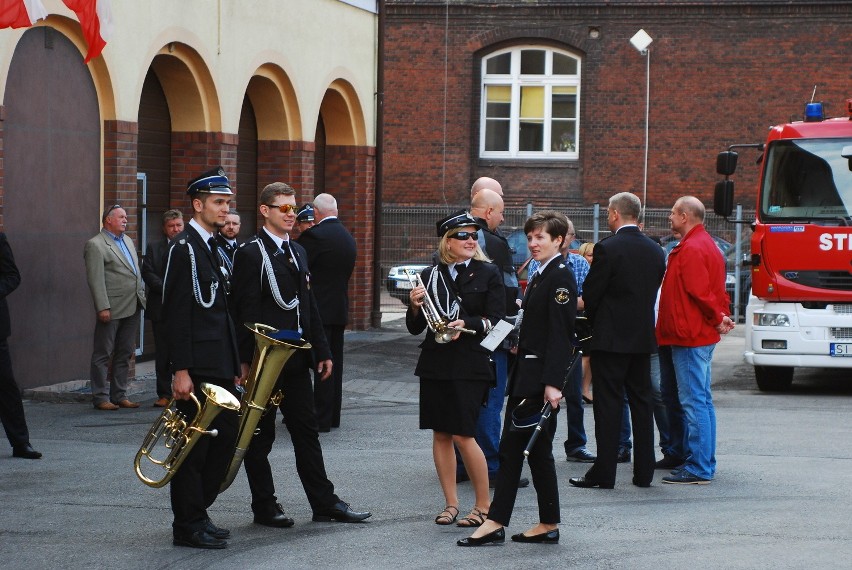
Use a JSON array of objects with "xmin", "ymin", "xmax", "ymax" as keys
[{"xmin": 219, "ymin": 323, "xmax": 311, "ymax": 493}]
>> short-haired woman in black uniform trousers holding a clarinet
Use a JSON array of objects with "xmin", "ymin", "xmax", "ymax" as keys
[{"xmin": 457, "ymin": 211, "xmax": 577, "ymax": 546}]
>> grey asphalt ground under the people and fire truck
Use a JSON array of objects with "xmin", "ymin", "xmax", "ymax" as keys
[{"xmin": 0, "ymin": 321, "xmax": 852, "ymax": 569}]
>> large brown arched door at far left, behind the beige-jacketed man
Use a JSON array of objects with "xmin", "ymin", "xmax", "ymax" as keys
[{"xmin": 3, "ymin": 26, "xmax": 101, "ymax": 387}]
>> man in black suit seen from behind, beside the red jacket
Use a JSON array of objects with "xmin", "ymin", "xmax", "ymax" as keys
[{"xmin": 569, "ymin": 192, "xmax": 666, "ymax": 489}]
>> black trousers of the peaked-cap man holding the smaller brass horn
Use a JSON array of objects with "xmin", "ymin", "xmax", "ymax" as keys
[{"xmin": 170, "ymin": 376, "xmax": 239, "ymax": 536}]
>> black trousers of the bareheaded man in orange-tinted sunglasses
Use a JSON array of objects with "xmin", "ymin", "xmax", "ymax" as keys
[{"xmin": 244, "ymin": 360, "xmax": 340, "ymax": 514}]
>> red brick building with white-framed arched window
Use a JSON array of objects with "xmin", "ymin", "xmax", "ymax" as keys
[{"xmin": 383, "ymin": 0, "xmax": 852, "ymax": 207}]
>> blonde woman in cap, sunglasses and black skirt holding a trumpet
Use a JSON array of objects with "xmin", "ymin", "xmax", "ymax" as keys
[{"xmin": 405, "ymin": 211, "xmax": 506, "ymax": 527}]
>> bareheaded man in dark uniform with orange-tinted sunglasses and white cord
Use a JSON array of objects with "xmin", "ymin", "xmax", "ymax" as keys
[{"xmin": 231, "ymin": 182, "xmax": 371, "ymax": 528}]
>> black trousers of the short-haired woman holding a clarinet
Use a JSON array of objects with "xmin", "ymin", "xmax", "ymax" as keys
[{"xmin": 488, "ymin": 397, "xmax": 560, "ymax": 526}]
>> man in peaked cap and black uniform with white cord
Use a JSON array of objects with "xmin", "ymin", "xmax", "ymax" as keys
[{"xmin": 162, "ymin": 167, "xmax": 240, "ymax": 548}]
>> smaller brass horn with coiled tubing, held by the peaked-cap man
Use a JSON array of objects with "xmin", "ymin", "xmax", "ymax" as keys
[{"xmin": 133, "ymin": 383, "xmax": 240, "ymax": 488}]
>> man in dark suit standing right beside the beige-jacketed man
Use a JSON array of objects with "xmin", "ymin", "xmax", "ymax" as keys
[{"xmin": 142, "ymin": 210, "xmax": 183, "ymax": 408}]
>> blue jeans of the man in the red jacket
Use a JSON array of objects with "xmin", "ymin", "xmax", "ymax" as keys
[{"xmin": 671, "ymin": 344, "xmax": 716, "ymax": 479}]
